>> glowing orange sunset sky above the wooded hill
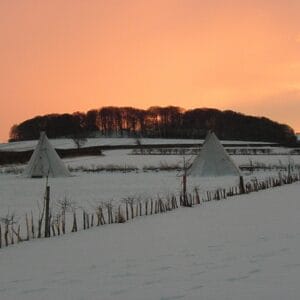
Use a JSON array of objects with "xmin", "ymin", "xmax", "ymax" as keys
[{"xmin": 0, "ymin": 0, "xmax": 300, "ymax": 140}]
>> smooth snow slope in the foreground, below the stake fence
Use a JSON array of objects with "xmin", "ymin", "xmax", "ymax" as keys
[{"xmin": 0, "ymin": 183, "xmax": 300, "ymax": 300}]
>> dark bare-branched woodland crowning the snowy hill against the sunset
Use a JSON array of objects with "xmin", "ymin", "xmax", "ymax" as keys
[{"xmin": 10, "ymin": 106, "xmax": 296, "ymax": 144}]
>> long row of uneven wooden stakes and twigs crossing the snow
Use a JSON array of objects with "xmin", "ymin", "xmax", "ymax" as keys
[{"xmin": 0, "ymin": 171, "xmax": 300, "ymax": 248}]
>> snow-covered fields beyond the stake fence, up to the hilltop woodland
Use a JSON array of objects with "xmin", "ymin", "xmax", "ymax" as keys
[{"xmin": 0, "ymin": 138, "xmax": 300, "ymax": 238}]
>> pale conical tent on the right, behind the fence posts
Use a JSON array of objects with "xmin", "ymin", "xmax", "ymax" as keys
[{"xmin": 188, "ymin": 132, "xmax": 242, "ymax": 177}]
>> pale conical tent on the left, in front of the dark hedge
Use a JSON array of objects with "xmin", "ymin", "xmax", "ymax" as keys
[{"xmin": 23, "ymin": 132, "xmax": 71, "ymax": 178}]
